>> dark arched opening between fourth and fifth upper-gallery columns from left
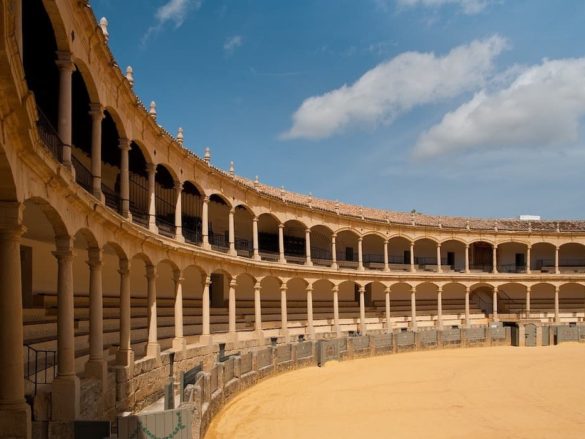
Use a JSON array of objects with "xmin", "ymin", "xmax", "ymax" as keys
[{"xmin": 154, "ymin": 165, "xmax": 177, "ymax": 238}]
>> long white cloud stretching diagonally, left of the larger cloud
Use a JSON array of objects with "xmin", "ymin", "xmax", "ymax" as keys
[{"xmin": 281, "ymin": 35, "xmax": 506, "ymax": 139}]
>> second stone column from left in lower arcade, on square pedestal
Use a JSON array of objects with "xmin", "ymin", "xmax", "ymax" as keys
[{"xmin": 52, "ymin": 236, "xmax": 80, "ymax": 421}]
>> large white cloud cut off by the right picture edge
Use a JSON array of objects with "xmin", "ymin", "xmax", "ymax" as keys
[{"xmin": 414, "ymin": 58, "xmax": 585, "ymax": 158}]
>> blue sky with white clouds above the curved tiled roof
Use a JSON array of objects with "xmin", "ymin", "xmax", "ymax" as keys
[{"xmin": 91, "ymin": 0, "xmax": 585, "ymax": 219}]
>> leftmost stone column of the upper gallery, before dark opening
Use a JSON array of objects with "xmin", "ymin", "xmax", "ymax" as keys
[{"xmin": 56, "ymin": 51, "xmax": 75, "ymax": 168}]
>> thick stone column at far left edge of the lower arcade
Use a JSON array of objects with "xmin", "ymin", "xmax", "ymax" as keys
[{"xmin": 0, "ymin": 206, "xmax": 32, "ymax": 439}]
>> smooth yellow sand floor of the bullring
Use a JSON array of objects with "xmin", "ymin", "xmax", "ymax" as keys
[{"xmin": 205, "ymin": 343, "xmax": 585, "ymax": 439}]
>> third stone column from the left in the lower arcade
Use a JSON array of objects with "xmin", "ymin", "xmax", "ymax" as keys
[{"xmin": 85, "ymin": 247, "xmax": 108, "ymax": 382}]
